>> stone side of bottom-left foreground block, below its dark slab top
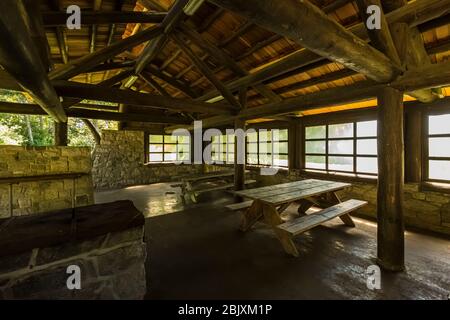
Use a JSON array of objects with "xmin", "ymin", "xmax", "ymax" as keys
[{"xmin": 0, "ymin": 227, "xmax": 146, "ymax": 299}]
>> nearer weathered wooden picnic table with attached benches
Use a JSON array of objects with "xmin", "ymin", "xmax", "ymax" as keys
[{"xmin": 234, "ymin": 179, "xmax": 367, "ymax": 257}]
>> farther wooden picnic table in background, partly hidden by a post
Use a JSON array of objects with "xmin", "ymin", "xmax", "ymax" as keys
[{"xmin": 171, "ymin": 170, "xmax": 256, "ymax": 203}]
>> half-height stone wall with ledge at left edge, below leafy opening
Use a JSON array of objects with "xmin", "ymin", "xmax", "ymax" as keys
[{"xmin": 0, "ymin": 146, "xmax": 94, "ymax": 218}]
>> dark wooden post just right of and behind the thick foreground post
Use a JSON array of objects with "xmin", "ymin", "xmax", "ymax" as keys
[{"xmin": 405, "ymin": 108, "xmax": 422, "ymax": 183}]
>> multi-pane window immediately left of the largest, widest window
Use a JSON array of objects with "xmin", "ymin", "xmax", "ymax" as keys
[{"xmin": 246, "ymin": 129, "xmax": 289, "ymax": 168}]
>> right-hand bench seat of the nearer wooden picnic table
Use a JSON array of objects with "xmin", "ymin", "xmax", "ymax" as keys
[{"xmin": 277, "ymin": 199, "xmax": 367, "ymax": 237}]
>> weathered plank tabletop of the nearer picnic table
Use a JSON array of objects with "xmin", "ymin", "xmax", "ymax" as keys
[{"xmin": 235, "ymin": 179, "xmax": 351, "ymax": 205}]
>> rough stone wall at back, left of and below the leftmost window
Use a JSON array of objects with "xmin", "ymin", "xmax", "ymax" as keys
[{"xmin": 92, "ymin": 131, "xmax": 203, "ymax": 190}]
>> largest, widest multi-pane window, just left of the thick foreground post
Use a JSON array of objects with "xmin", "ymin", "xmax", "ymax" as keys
[{"xmin": 305, "ymin": 120, "xmax": 378, "ymax": 176}]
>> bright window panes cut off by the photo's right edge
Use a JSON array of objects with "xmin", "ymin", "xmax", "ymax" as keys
[{"xmin": 426, "ymin": 114, "xmax": 450, "ymax": 182}]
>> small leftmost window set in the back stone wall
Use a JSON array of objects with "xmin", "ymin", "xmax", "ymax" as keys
[{"xmin": 148, "ymin": 134, "xmax": 190, "ymax": 163}]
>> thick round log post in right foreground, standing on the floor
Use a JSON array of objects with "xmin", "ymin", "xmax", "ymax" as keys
[{"xmin": 377, "ymin": 88, "xmax": 405, "ymax": 271}]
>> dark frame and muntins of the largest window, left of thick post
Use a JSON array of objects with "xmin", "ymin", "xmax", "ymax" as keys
[{"xmin": 301, "ymin": 119, "xmax": 379, "ymax": 181}]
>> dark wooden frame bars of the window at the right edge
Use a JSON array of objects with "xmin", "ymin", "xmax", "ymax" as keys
[{"xmin": 422, "ymin": 106, "xmax": 450, "ymax": 182}]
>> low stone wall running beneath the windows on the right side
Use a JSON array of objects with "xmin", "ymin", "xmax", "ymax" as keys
[{"xmin": 205, "ymin": 165, "xmax": 450, "ymax": 235}]
